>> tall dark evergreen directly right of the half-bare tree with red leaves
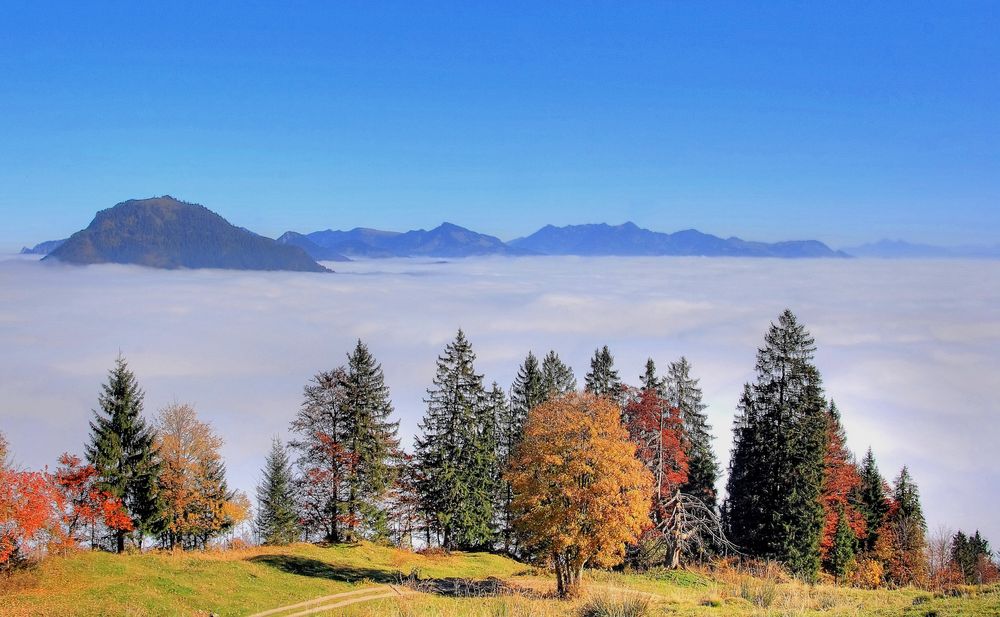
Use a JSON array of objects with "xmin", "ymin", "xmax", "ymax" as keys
[{"xmin": 343, "ymin": 340, "xmax": 399, "ymax": 541}]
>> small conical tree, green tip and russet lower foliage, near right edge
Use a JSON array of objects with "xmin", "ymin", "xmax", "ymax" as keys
[{"xmin": 875, "ymin": 466, "xmax": 927, "ymax": 586}]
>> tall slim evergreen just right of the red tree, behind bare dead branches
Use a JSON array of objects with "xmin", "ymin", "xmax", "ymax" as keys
[{"xmin": 664, "ymin": 356, "xmax": 719, "ymax": 510}]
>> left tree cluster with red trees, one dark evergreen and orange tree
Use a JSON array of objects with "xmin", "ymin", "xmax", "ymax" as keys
[{"xmin": 0, "ymin": 356, "xmax": 250, "ymax": 569}]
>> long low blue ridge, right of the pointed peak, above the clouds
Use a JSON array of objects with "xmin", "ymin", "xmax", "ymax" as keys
[{"xmin": 508, "ymin": 222, "xmax": 847, "ymax": 258}]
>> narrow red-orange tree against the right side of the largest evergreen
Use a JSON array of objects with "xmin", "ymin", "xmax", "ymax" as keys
[{"xmin": 819, "ymin": 402, "xmax": 867, "ymax": 577}]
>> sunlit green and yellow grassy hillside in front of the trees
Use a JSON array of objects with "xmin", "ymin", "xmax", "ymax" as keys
[{"xmin": 0, "ymin": 544, "xmax": 1000, "ymax": 617}]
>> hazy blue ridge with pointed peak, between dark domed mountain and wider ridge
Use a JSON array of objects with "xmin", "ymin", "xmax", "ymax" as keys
[{"xmin": 294, "ymin": 223, "xmax": 531, "ymax": 258}]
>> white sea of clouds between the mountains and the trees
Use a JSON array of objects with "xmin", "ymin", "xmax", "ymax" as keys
[{"xmin": 0, "ymin": 257, "xmax": 1000, "ymax": 542}]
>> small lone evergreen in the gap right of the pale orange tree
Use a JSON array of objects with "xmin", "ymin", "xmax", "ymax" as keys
[{"xmin": 255, "ymin": 437, "xmax": 299, "ymax": 544}]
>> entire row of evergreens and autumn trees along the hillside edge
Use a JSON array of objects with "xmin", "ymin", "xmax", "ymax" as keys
[{"xmin": 0, "ymin": 311, "xmax": 996, "ymax": 592}]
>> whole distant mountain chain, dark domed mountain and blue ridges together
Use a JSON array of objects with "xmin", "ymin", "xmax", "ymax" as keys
[{"xmin": 21, "ymin": 195, "xmax": 1000, "ymax": 272}]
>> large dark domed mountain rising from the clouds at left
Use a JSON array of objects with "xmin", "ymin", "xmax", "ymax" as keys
[{"xmin": 43, "ymin": 195, "xmax": 328, "ymax": 272}]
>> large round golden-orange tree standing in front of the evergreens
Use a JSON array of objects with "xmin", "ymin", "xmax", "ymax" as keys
[{"xmin": 508, "ymin": 394, "xmax": 653, "ymax": 597}]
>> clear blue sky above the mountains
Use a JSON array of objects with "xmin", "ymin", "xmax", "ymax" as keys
[{"xmin": 0, "ymin": 1, "xmax": 1000, "ymax": 249}]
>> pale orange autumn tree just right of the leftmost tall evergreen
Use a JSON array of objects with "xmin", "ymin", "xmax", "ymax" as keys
[{"xmin": 156, "ymin": 403, "xmax": 249, "ymax": 549}]
